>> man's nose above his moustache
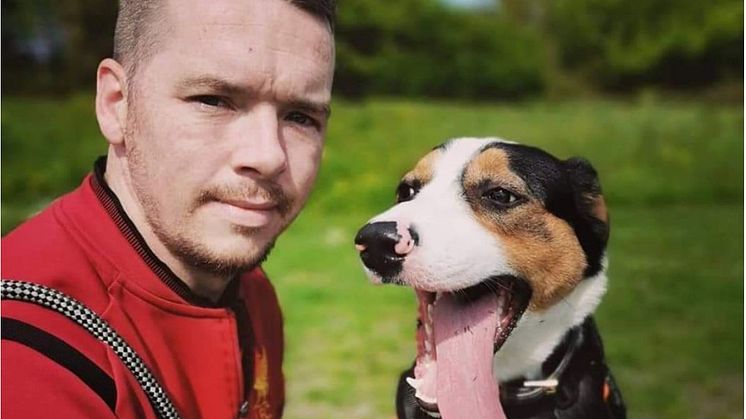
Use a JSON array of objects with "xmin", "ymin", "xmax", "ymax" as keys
[{"xmin": 233, "ymin": 105, "xmax": 287, "ymax": 179}]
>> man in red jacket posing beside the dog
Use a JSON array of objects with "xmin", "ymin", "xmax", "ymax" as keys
[{"xmin": 2, "ymin": 0, "xmax": 334, "ymax": 418}]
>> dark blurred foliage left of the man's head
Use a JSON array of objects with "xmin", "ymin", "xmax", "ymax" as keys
[{"xmin": 2, "ymin": 0, "xmax": 118, "ymax": 95}]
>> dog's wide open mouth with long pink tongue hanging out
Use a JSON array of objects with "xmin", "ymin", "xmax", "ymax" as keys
[{"xmin": 407, "ymin": 276, "xmax": 531, "ymax": 418}]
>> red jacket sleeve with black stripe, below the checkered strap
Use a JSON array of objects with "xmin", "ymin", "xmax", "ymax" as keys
[{"xmin": 0, "ymin": 300, "xmax": 117, "ymax": 418}]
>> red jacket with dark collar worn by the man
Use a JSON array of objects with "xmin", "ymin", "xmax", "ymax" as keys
[{"xmin": 2, "ymin": 159, "xmax": 284, "ymax": 419}]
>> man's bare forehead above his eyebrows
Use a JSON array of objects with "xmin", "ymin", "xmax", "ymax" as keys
[{"xmin": 148, "ymin": 0, "xmax": 334, "ymax": 97}]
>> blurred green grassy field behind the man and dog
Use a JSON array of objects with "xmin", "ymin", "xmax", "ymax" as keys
[{"xmin": 2, "ymin": 95, "xmax": 743, "ymax": 419}]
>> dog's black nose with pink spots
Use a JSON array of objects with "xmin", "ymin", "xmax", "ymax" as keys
[{"xmin": 355, "ymin": 221, "xmax": 417, "ymax": 281}]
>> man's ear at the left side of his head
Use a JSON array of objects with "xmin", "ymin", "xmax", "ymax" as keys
[{"xmin": 96, "ymin": 58, "xmax": 127, "ymax": 146}]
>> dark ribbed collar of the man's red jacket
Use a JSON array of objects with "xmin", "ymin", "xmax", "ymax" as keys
[{"xmin": 91, "ymin": 156, "xmax": 239, "ymax": 308}]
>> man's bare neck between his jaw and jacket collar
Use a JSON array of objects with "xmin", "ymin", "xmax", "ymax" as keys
[{"xmin": 104, "ymin": 150, "xmax": 231, "ymax": 302}]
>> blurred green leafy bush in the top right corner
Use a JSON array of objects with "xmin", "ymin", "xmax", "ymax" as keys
[{"xmin": 546, "ymin": 0, "xmax": 743, "ymax": 88}]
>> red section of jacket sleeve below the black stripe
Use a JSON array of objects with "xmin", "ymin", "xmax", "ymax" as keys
[{"xmin": 1, "ymin": 334, "xmax": 116, "ymax": 419}]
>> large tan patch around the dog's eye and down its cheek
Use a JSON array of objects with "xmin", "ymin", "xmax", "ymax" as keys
[{"xmin": 464, "ymin": 149, "xmax": 587, "ymax": 311}]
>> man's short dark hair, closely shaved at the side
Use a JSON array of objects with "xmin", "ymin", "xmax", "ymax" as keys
[{"xmin": 113, "ymin": 0, "xmax": 336, "ymax": 78}]
